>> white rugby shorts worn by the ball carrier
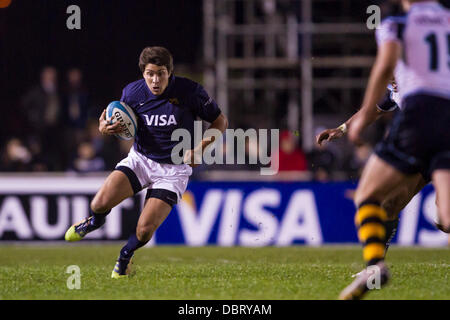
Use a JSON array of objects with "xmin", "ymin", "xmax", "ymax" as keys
[{"xmin": 116, "ymin": 146, "xmax": 192, "ymax": 203}]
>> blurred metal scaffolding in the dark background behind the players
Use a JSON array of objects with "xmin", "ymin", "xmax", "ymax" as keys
[{"xmin": 203, "ymin": 0, "xmax": 375, "ymax": 151}]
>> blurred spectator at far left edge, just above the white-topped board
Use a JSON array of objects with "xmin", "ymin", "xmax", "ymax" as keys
[{"xmin": 0, "ymin": 138, "xmax": 32, "ymax": 171}]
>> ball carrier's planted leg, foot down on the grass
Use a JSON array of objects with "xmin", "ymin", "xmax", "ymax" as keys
[{"xmin": 111, "ymin": 189, "xmax": 177, "ymax": 278}]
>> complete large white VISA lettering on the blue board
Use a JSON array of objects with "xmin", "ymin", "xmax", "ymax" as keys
[{"xmin": 177, "ymin": 188, "xmax": 323, "ymax": 246}]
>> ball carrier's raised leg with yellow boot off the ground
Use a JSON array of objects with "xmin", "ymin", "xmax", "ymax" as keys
[{"xmin": 65, "ymin": 170, "xmax": 134, "ymax": 241}]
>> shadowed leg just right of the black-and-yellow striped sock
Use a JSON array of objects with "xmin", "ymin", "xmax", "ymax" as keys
[{"xmin": 381, "ymin": 173, "xmax": 428, "ymax": 255}]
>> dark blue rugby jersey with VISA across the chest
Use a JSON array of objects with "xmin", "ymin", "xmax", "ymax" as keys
[{"xmin": 120, "ymin": 75, "xmax": 221, "ymax": 163}]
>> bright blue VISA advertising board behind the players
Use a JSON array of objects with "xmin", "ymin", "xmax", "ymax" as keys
[{"xmin": 154, "ymin": 182, "xmax": 447, "ymax": 246}]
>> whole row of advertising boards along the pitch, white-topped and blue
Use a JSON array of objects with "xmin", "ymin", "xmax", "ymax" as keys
[{"xmin": 0, "ymin": 176, "xmax": 447, "ymax": 246}]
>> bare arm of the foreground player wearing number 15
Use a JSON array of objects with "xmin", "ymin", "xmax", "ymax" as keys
[{"xmin": 348, "ymin": 41, "xmax": 401, "ymax": 143}]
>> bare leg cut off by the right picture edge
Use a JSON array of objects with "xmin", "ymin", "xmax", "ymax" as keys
[{"xmin": 432, "ymin": 169, "xmax": 450, "ymax": 233}]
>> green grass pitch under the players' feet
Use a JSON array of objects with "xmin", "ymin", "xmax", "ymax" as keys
[{"xmin": 0, "ymin": 244, "xmax": 450, "ymax": 300}]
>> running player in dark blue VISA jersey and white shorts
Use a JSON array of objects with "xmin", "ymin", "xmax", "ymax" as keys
[{"xmin": 65, "ymin": 47, "xmax": 228, "ymax": 278}]
